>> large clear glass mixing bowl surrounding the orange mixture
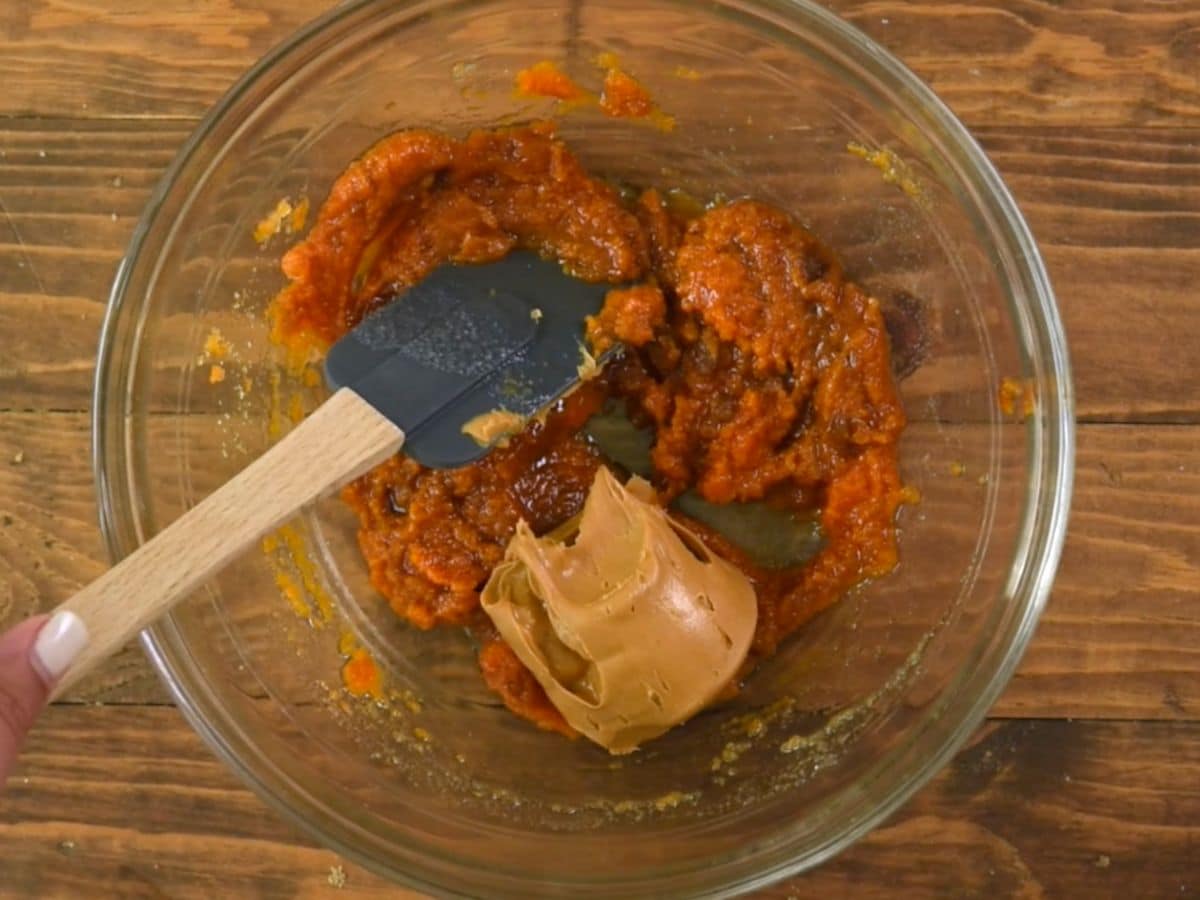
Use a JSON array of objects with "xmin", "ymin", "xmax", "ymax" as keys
[{"xmin": 95, "ymin": 0, "xmax": 1073, "ymax": 896}]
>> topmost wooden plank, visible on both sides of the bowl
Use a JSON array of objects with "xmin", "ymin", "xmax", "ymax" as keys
[{"xmin": 0, "ymin": 0, "xmax": 1200, "ymax": 126}]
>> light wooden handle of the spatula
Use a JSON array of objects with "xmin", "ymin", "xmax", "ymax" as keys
[{"xmin": 54, "ymin": 388, "xmax": 404, "ymax": 697}]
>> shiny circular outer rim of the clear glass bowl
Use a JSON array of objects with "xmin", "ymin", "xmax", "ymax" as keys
[{"xmin": 91, "ymin": 0, "xmax": 1075, "ymax": 895}]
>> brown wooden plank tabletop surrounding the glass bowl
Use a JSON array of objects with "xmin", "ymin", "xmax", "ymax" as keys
[{"xmin": 0, "ymin": 0, "xmax": 1200, "ymax": 900}]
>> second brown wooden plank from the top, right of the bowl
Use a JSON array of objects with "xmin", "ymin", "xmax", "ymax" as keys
[{"xmin": 978, "ymin": 127, "xmax": 1200, "ymax": 421}]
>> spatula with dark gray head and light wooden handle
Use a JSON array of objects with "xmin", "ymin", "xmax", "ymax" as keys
[{"xmin": 54, "ymin": 253, "xmax": 611, "ymax": 696}]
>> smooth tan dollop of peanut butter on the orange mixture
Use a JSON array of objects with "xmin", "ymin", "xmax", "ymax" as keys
[{"xmin": 482, "ymin": 467, "xmax": 757, "ymax": 754}]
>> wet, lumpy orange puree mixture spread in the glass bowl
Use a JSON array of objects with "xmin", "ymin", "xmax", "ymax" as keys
[{"xmin": 270, "ymin": 124, "xmax": 907, "ymax": 734}]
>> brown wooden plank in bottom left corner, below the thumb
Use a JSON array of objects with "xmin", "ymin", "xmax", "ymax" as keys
[{"xmin": 0, "ymin": 707, "xmax": 410, "ymax": 900}]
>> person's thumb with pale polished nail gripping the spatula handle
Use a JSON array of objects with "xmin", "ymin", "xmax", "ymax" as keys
[{"xmin": 0, "ymin": 612, "xmax": 88, "ymax": 791}]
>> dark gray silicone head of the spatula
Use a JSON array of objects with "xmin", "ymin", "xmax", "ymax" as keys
[{"xmin": 325, "ymin": 252, "xmax": 612, "ymax": 468}]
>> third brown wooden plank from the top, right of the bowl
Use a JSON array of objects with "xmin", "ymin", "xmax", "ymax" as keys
[{"xmin": 996, "ymin": 426, "xmax": 1200, "ymax": 720}]
